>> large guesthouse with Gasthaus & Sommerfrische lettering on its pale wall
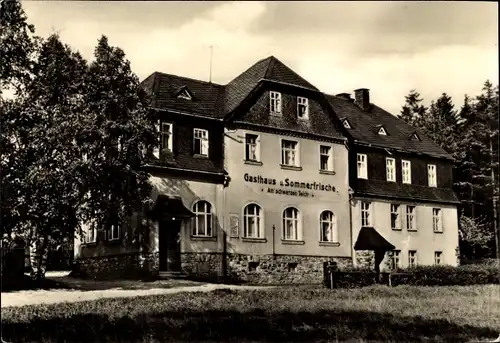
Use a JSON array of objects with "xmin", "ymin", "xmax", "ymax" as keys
[{"xmin": 75, "ymin": 57, "xmax": 458, "ymax": 283}]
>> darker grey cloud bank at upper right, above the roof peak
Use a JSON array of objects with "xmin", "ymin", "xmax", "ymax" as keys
[{"xmin": 252, "ymin": 1, "xmax": 498, "ymax": 56}]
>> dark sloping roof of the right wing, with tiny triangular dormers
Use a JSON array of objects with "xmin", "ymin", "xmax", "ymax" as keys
[{"xmin": 326, "ymin": 95, "xmax": 451, "ymax": 159}]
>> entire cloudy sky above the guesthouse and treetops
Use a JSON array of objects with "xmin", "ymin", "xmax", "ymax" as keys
[{"xmin": 23, "ymin": 1, "xmax": 499, "ymax": 114}]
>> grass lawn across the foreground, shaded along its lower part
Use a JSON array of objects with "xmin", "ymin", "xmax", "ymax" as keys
[{"xmin": 2, "ymin": 285, "xmax": 500, "ymax": 343}]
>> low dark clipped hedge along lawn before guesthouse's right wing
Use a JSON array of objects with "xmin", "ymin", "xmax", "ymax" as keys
[{"xmin": 325, "ymin": 265, "xmax": 500, "ymax": 288}]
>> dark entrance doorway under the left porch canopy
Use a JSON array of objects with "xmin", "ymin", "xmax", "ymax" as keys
[{"xmin": 158, "ymin": 220, "xmax": 181, "ymax": 272}]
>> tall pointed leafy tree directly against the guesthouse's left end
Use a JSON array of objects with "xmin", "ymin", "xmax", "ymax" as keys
[{"xmin": 78, "ymin": 36, "xmax": 158, "ymax": 253}]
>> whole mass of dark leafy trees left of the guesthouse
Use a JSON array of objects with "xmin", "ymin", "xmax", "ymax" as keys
[{"xmin": 0, "ymin": 1, "xmax": 156, "ymax": 278}]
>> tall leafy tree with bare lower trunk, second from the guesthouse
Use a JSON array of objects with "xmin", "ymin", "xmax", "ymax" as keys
[{"xmin": 14, "ymin": 35, "xmax": 87, "ymax": 279}]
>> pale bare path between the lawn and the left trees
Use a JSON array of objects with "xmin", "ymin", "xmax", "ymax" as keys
[{"xmin": 2, "ymin": 284, "xmax": 269, "ymax": 308}]
